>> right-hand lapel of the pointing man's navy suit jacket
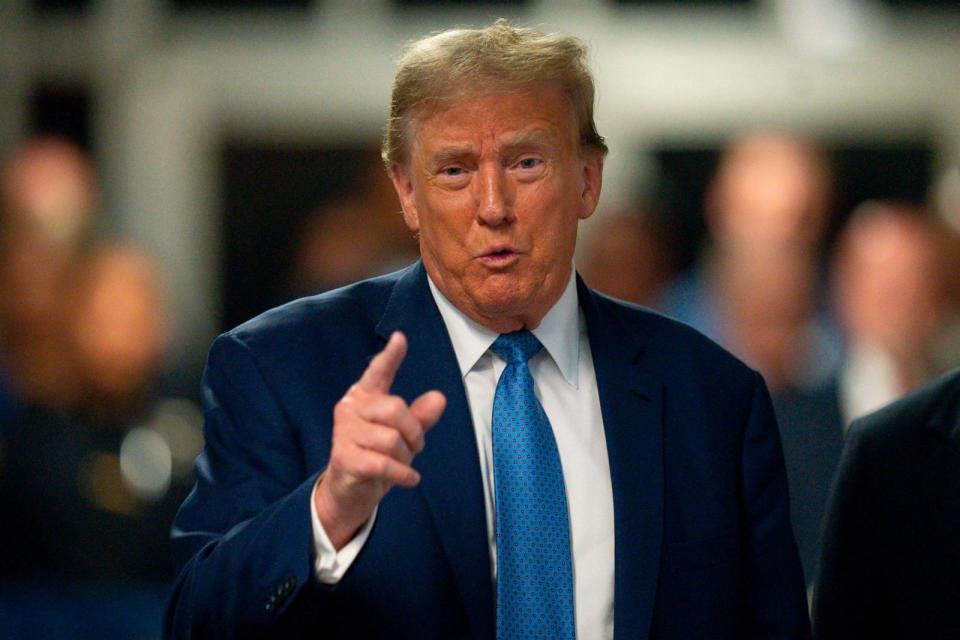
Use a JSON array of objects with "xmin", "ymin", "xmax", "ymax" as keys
[{"xmin": 577, "ymin": 278, "xmax": 664, "ymax": 639}]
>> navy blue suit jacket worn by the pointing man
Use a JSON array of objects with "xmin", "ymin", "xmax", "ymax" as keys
[{"xmin": 165, "ymin": 262, "xmax": 809, "ymax": 640}]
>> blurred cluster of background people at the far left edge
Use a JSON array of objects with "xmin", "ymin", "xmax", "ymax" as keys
[{"xmin": 0, "ymin": 138, "xmax": 203, "ymax": 638}]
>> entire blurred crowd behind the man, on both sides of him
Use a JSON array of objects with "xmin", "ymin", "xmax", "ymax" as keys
[{"xmin": 0, "ymin": 132, "xmax": 960, "ymax": 637}]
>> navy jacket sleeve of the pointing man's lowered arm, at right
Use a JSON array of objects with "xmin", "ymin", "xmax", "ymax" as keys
[{"xmin": 741, "ymin": 373, "xmax": 810, "ymax": 639}]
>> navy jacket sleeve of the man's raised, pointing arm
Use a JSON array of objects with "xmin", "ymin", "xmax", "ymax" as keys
[{"xmin": 164, "ymin": 334, "xmax": 333, "ymax": 638}]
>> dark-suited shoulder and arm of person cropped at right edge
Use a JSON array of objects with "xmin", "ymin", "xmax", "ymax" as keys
[{"xmin": 813, "ymin": 370, "xmax": 960, "ymax": 640}]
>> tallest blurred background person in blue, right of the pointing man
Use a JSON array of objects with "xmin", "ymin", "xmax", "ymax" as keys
[{"xmin": 662, "ymin": 131, "xmax": 843, "ymax": 591}]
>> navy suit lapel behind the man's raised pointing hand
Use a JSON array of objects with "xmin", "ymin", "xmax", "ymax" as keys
[{"xmin": 376, "ymin": 262, "xmax": 495, "ymax": 638}]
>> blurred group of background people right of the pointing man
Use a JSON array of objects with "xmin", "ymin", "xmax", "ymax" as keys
[{"xmin": 578, "ymin": 132, "xmax": 960, "ymax": 586}]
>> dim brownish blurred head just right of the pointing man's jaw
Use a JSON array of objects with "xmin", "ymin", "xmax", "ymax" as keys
[{"xmin": 579, "ymin": 205, "xmax": 673, "ymax": 307}]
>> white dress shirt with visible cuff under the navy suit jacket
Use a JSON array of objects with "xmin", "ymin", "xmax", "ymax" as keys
[{"xmin": 311, "ymin": 273, "xmax": 614, "ymax": 639}]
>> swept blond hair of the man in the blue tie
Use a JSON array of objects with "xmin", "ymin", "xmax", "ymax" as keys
[{"xmin": 382, "ymin": 18, "xmax": 607, "ymax": 168}]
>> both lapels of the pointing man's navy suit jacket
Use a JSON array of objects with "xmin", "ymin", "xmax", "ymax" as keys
[{"xmin": 376, "ymin": 262, "xmax": 664, "ymax": 640}]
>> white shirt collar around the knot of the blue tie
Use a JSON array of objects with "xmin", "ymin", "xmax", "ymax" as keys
[{"xmin": 427, "ymin": 269, "xmax": 580, "ymax": 387}]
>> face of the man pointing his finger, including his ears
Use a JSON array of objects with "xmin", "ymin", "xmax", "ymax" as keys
[{"xmin": 392, "ymin": 88, "xmax": 603, "ymax": 333}]
